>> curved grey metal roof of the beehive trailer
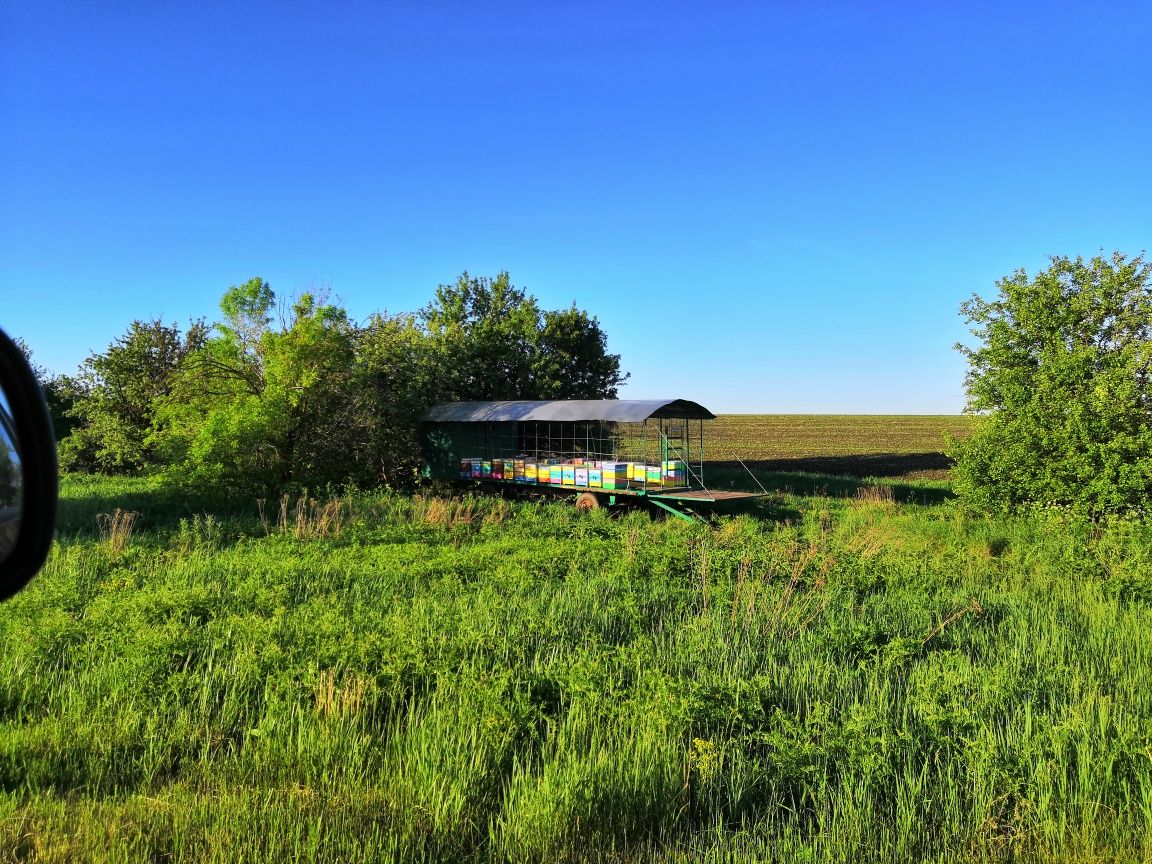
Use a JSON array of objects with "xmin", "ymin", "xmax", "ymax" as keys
[{"xmin": 424, "ymin": 399, "xmax": 715, "ymax": 423}]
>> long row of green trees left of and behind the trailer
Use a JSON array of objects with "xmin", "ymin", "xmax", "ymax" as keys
[{"xmin": 43, "ymin": 273, "xmax": 627, "ymax": 493}]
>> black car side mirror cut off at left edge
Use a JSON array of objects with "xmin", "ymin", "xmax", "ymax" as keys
[{"xmin": 0, "ymin": 331, "xmax": 60, "ymax": 600}]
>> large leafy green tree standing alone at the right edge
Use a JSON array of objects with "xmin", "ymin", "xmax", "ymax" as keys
[{"xmin": 953, "ymin": 252, "xmax": 1152, "ymax": 514}]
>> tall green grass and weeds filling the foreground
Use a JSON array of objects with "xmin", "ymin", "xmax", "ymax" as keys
[{"xmin": 0, "ymin": 478, "xmax": 1152, "ymax": 862}]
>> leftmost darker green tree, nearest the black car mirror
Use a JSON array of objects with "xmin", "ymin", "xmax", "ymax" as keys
[{"xmin": 58, "ymin": 320, "xmax": 206, "ymax": 473}]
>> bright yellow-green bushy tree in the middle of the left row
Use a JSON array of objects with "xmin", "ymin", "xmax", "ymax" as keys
[{"xmin": 156, "ymin": 289, "xmax": 355, "ymax": 493}]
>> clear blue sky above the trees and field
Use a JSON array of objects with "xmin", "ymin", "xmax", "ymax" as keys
[{"xmin": 0, "ymin": 0, "xmax": 1152, "ymax": 414}]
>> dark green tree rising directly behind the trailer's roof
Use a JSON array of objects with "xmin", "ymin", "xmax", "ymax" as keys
[{"xmin": 419, "ymin": 272, "xmax": 628, "ymax": 400}]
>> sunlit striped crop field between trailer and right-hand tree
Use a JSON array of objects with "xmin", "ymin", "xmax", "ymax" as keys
[{"xmin": 704, "ymin": 414, "xmax": 975, "ymax": 479}]
